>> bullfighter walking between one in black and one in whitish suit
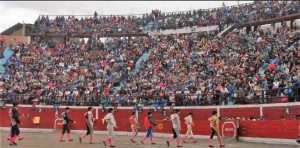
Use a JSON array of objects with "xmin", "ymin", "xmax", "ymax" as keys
[{"xmin": 79, "ymin": 107, "xmax": 94, "ymax": 144}]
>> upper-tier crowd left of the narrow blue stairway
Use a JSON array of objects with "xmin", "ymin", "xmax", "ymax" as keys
[{"xmin": 33, "ymin": 12, "xmax": 153, "ymax": 36}]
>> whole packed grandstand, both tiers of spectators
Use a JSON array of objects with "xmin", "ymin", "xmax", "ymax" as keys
[{"xmin": 0, "ymin": 1, "xmax": 300, "ymax": 106}]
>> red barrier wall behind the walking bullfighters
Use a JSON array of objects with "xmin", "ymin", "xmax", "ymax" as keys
[{"xmin": 0, "ymin": 105, "xmax": 300, "ymax": 139}]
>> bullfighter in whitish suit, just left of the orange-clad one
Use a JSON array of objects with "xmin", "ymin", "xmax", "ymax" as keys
[{"xmin": 103, "ymin": 108, "xmax": 118, "ymax": 147}]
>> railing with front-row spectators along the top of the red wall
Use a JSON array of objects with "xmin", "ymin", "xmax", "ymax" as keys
[{"xmin": 0, "ymin": 86, "xmax": 300, "ymax": 109}]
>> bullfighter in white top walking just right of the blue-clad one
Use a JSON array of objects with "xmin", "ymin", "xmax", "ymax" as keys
[{"xmin": 167, "ymin": 109, "xmax": 182, "ymax": 147}]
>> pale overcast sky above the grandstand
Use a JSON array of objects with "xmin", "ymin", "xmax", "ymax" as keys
[{"xmin": 0, "ymin": 1, "xmax": 253, "ymax": 33}]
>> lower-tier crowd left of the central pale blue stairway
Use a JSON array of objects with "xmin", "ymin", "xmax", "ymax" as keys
[{"xmin": 0, "ymin": 34, "xmax": 152, "ymax": 105}]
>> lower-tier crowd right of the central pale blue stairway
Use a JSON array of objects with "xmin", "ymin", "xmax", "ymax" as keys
[{"xmin": 118, "ymin": 27, "xmax": 300, "ymax": 105}]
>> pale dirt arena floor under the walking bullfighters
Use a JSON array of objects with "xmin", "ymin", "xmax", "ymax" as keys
[{"xmin": 0, "ymin": 132, "xmax": 300, "ymax": 148}]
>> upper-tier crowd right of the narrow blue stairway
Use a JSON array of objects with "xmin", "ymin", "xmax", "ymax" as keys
[{"xmin": 155, "ymin": 1, "xmax": 300, "ymax": 31}]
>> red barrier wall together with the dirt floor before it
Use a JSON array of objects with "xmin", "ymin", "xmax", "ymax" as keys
[{"xmin": 0, "ymin": 104, "xmax": 299, "ymax": 148}]
